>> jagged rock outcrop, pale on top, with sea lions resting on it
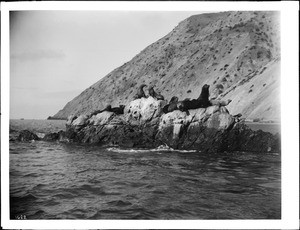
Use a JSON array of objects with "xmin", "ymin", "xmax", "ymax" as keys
[{"xmin": 10, "ymin": 97, "xmax": 281, "ymax": 153}]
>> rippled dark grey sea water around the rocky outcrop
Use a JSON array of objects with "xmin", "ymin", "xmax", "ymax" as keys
[{"xmin": 9, "ymin": 120, "xmax": 281, "ymax": 219}]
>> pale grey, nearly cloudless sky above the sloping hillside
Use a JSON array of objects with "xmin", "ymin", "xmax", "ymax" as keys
[{"xmin": 10, "ymin": 10, "xmax": 201, "ymax": 119}]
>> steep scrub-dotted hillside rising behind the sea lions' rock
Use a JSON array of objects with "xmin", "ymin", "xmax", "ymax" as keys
[{"xmin": 54, "ymin": 11, "xmax": 280, "ymax": 121}]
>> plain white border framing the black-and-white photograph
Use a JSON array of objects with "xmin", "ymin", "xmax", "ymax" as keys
[{"xmin": 1, "ymin": 1, "xmax": 299, "ymax": 229}]
